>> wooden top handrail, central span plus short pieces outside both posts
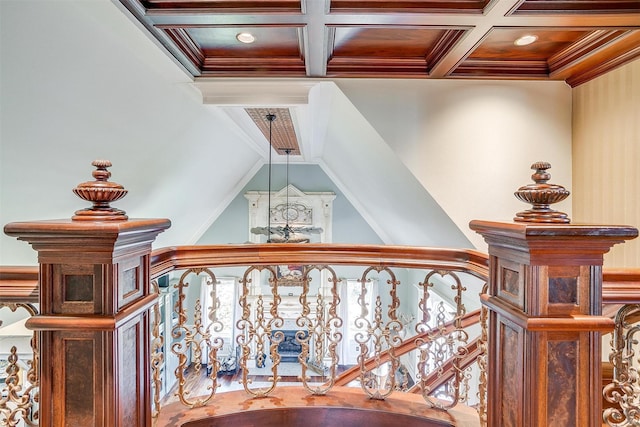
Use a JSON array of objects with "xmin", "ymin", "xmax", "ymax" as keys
[{"xmin": 0, "ymin": 251, "xmax": 640, "ymax": 304}]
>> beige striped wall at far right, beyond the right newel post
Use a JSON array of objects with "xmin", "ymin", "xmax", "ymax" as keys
[{"xmin": 572, "ymin": 59, "xmax": 640, "ymax": 268}]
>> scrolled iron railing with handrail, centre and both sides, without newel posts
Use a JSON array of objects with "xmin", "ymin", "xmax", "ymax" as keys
[{"xmin": 5, "ymin": 252, "xmax": 640, "ymax": 426}]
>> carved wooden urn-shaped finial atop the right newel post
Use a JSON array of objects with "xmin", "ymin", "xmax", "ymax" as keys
[{"xmin": 513, "ymin": 162, "xmax": 571, "ymax": 224}]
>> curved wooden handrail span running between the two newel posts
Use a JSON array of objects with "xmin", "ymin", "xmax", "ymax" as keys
[{"xmin": 151, "ymin": 243, "xmax": 489, "ymax": 280}]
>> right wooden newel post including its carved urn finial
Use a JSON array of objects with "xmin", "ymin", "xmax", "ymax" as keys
[{"xmin": 470, "ymin": 163, "xmax": 638, "ymax": 427}]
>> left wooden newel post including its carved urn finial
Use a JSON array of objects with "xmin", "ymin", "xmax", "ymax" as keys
[{"xmin": 4, "ymin": 161, "xmax": 171, "ymax": 427}]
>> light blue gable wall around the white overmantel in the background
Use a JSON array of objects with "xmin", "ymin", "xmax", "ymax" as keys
[{"xmin": 197, "ymin": 165, "xmax": 382, "ymax": 245}]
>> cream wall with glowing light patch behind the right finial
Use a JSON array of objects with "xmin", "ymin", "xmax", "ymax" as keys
[{"xmin": 338, "ymin": 79, "xmax": 572, "ymax": 252}]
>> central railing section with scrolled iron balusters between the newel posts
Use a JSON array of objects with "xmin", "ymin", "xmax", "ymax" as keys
[{"xmin": 151, "ymin": 244, "xmax": 487, "ymax": 424}]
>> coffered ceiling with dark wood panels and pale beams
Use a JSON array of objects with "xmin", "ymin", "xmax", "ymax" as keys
[{"xmin": 119, "ymin": 0, "xmax": 640, "ymax": 86}]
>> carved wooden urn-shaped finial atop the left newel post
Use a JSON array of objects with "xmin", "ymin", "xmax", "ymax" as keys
[{"xmin": 72, "ymin": 160, "xmax": 127, "ymax": 221}]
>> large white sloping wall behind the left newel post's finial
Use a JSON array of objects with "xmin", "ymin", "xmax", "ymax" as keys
[{"xmin": 0, "ymin": 0, "xmax": 258, "ymax": 265}]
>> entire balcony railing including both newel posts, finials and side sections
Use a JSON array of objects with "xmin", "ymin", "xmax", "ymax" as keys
[{"xmin": 0, "ymin": 160, "xmax": 640, "ymax": 427}]
